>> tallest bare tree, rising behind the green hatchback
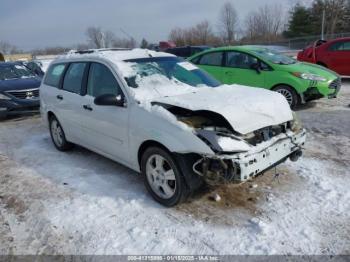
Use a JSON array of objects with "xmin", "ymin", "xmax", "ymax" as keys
[{"xmin": 218, "ymin": 2, "xmax": 238, "ymax": 44}]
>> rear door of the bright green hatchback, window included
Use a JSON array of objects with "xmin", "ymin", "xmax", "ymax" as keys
[{"xmin": 192, "ymin": 51, "xmax": 224, "ymax": 82}]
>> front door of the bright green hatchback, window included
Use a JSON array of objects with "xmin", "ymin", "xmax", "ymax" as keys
[{"xmin": 223, "ymin": 51, "xmax": 265, "ymax": 87}]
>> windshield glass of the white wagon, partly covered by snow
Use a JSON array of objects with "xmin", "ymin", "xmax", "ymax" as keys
[{"xmin": 125, "ymin": 57, "xmax": 220, "ymax": 88}]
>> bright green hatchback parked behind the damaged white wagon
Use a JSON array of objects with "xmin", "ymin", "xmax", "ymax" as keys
[{"xmin": 188, "ymin": 46, "xmax": 341, "ymax": 108}]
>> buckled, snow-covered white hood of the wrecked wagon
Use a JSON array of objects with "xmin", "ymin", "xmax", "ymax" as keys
[{"xmin": 153, "ymin": 85, "xmax": 293, "ymax": 134}]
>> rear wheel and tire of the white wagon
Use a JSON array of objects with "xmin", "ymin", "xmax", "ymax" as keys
[{"xmin": 49, "ymin": 116, "xmax": 73, "ymax": 151}]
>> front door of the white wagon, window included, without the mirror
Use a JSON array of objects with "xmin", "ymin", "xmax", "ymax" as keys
[{"xmin": 80, "ymin": 62, "xmax": 129, "ymax": 163}]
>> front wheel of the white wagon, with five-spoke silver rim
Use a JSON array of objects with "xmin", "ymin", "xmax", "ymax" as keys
[{"xmin": 141, "ymin": 147, "xmax": 190, "ymax": 207}]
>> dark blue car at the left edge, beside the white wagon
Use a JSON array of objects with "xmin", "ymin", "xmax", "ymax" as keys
[{"xmin": 0, "ymin": 62, "xmax": 40, "ymax": 118}]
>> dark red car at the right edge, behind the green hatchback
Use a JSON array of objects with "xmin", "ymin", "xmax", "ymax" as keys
[{"xmin": 298, "ymin": 37, "xmax": 350, "ymax": 77}]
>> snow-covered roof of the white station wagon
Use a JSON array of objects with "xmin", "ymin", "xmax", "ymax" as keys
[{"xmin": 58, "ymin": 48, "xmax": 174, "ymax": 63}]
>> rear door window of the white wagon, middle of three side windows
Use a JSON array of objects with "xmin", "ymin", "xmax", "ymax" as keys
[{"xmin": 63, "ymin": 63, "xmax": 86, "ymax": 94}]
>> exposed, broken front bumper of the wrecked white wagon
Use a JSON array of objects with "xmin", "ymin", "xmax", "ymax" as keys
[{"xmin": 193, "ymin": 129, "xmax": 306, "ymax": 184}]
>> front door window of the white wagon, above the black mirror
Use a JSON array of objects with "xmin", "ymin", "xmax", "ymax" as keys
[{"xmin": 87, "ymin": 63, "xmax": 122, "ymax": 97}]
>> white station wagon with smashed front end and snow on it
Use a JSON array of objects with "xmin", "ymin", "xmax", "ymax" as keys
[{"xmin": 40, "ymin": 49, "xmax": 305, "ymax": 206}]
